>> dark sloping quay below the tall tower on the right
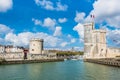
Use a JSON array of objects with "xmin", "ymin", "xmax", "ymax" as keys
[{"xmin": 84, "ymin": 58, "xmax": 120, "ymax": 67}]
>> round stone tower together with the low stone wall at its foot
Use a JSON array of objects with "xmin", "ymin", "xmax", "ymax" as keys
[{"xmin": 28, "ymin": 38, "xmax": 56, "ymax": 60}]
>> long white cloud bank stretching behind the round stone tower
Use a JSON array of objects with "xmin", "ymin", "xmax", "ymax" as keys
[{"xmin": 4, "ymin": 32, "xmax": 78, "ymax": 48}]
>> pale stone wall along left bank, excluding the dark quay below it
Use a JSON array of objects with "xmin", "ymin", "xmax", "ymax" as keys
[{"xmin": 0, "ymin": 53, "xmax": 56, "ymax": 61}]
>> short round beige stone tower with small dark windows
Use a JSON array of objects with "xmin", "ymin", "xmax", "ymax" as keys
[{"xmin": 29, "ymin": 38, "xmax": 44, "ymax": 54}]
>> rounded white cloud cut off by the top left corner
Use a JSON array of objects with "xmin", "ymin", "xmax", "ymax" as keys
[{"xmin": 0, "ymin": 0, "xmax": 13, "ymax": 12}]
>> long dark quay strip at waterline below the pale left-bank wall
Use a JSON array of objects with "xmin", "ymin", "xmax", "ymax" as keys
[{"xmin": 0, "ymin": 59, "xmax": 64, "ymax": 65}]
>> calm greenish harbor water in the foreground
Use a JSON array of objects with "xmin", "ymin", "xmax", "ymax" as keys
[{"xmin": 0, "ymin": 60, "xmax": 120, "ymax": 80}]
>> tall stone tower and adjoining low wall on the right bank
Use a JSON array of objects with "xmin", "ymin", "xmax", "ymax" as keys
[{"xmin": 84, "ymin": 23, "xmax": 120, "ymax": 58}]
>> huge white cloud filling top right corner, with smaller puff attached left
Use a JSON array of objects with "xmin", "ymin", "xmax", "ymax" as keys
[{"xmin": 74, "ymin": 0, "xmax": 120, "ymax": 28}]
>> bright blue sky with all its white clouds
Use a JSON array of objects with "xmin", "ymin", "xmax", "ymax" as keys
[{"xmin": 0, "ymin": 0, "xmax": 120, "ymax": 50}]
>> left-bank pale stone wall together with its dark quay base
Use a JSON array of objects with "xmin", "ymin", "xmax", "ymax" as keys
[{"xmin": 0, "ymin": 53, "xmax": 64, "ymax": 64}]
